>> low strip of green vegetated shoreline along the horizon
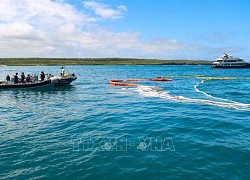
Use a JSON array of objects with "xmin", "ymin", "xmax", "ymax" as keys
[{"xmin": 0, "ymin": 58, "xmax": 212, "ymax": 66}]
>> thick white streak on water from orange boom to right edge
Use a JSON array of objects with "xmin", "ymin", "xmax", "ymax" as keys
[{"xmin": 136, "ymin": 85, "xmax": 250, "ymax": 111}]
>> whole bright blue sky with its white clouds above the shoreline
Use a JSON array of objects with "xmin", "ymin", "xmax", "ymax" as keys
[{"xmin": 0, "ymin": 0, "xmax": 250, "ymax": 60}]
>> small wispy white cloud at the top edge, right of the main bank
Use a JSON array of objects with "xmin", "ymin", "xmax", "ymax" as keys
[{"xmin": 82, "ymin": 1, "xmax": 127, "ymax": 19}]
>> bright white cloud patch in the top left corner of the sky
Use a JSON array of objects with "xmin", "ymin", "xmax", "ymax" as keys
[{"xmin": 0, "ymin": 0, "xmax": 96, "ymax": 25}]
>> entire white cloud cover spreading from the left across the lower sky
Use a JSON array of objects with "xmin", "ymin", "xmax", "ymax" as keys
[{"xmin": 0, "ymin": 0, "xmax": 243, "ymax": 59}]
